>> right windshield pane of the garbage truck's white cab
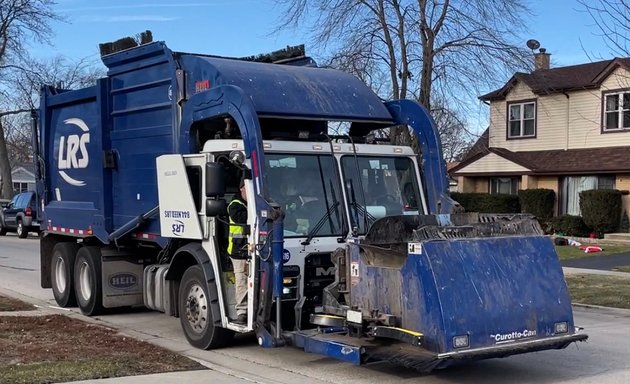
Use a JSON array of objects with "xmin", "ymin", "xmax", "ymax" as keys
[{"xmin": 341, "ymin": 156, "xmax": 421, "ymax": 233}]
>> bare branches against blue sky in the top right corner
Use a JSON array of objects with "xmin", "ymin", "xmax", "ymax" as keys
[{"xmin": 578, "ymin": 0, "xmax": 630, "ymax": 56}]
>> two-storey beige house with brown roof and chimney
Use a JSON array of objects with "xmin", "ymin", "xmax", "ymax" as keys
[{"xmin": 451, "ymin": 49, "xmax": 630, "ymax": 215}]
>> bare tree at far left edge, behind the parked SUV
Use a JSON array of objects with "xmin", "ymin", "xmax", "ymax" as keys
[{"xmin": 0, "ymin": 0, "xmax": 61, "ymax": 197}]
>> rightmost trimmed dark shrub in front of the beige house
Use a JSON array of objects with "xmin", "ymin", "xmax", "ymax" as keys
[{"xmin": 580, "ymin": 189, "xmax": 621, "ymax": 236}]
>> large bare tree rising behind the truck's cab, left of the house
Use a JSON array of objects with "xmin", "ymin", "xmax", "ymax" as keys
[{"xmin": 276, "ymin": 0, "xmax": 531, "ymax": 153}]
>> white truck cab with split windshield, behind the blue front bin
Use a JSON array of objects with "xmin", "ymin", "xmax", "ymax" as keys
[{"xmin": 186, "ymin": 137, "xmax": 426, "ymax": 329}]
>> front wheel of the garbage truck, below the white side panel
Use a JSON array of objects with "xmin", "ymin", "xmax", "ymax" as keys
[{"xmin": 178, "ymin": 265, "xmax": 234, "ymax": 349}]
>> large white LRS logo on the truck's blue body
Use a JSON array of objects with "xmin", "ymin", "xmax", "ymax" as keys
[{"xmin": 57, "ymin": 118, "xmax": 90, "ymax": 187}]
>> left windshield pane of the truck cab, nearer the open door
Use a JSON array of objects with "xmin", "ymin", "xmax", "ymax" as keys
[{"xmin": 265, "ymin": 153, "xmax": 343, "ymax": 237}]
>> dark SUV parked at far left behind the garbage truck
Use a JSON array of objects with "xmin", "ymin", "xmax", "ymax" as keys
[{"xmin": 0, "ymin": 192, "xmax": 39, "ymax": 239}]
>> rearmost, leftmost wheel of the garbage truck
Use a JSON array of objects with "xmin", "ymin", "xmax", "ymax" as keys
[{"xmin": 50, "ymin": 243, "xmax": 80, "ymax": 308}]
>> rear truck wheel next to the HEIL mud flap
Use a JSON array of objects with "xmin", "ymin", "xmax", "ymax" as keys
[{"xmin": 74, "ymin": 247, "xmax": 103, "ymax": 316}]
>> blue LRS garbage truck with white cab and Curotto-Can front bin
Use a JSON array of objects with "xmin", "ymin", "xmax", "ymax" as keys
[{"xmin": 33, "ymin": 42, "xmax": 587, "ymax": 371}]
